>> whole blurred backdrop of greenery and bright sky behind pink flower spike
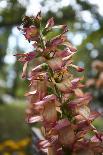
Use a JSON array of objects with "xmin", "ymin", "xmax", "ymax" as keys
[{"xmin": 0, "ymin": 0, "xmax": 103, "ymax": 155}]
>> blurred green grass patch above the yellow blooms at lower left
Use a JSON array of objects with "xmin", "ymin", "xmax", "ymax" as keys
[{"xmin": 0, "ymin": 103, "xmax": 30, "ymax": 141}]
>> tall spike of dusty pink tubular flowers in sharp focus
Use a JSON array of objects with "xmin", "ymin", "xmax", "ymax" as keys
[{"xmin": 16, "ymin": 12, "xmax": 103, "ymax": 155}]
